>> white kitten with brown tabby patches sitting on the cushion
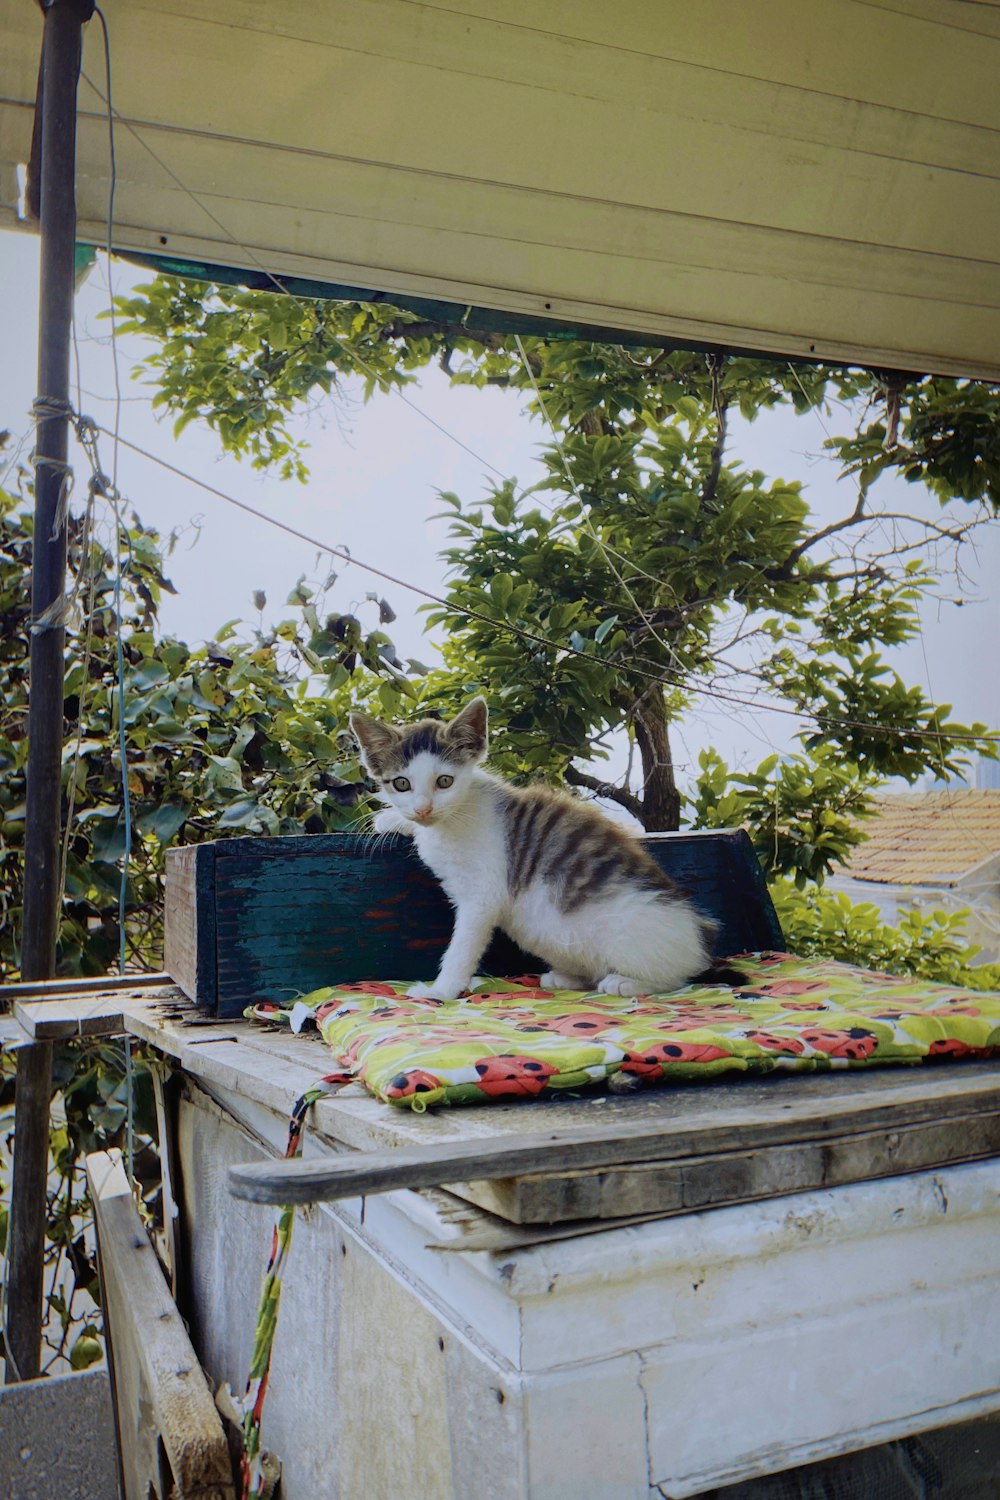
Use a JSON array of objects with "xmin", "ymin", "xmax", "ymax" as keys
[{"xmin": 351, "ymin": 698, "xmax": 712, "ymax": 1001}]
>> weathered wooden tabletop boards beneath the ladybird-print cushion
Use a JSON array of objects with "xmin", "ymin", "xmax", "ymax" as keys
[{"xmin": 7, "ymin": 977, "xmax": 1000, "ymax": 1227}]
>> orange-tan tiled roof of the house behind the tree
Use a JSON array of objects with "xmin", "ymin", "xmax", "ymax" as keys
[{"xmin": 843, "ymin": 788, "xmax": 1000, "ymax": 885}]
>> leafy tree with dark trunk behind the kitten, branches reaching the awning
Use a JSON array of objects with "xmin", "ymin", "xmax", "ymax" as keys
[{"xmin": 113, "ymin": 278, "xmax": 1000, "ymax": 882}]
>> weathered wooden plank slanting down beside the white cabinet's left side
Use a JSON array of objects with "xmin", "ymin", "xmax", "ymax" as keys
[{"xmin": 87, "ymin": 1152, "xmax": 235, "ymax": 1500}]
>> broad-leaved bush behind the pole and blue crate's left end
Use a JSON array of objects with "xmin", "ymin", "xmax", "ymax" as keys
[{"xmin": 0, "ymin": 456, "xmax": 411, "ymax": 977}]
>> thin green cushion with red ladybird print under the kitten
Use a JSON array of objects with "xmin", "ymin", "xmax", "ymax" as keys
[{"xmin": 247, "ymin": 953, "xmax": 1000, "ymax": 1110}]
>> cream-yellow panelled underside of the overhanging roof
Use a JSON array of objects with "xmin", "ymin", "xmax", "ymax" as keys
[{"xmin": 0, "ymin": 0, "xmax": 1000, "ymax": 380}]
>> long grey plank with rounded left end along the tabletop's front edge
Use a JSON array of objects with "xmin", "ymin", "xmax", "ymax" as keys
[{"xmin": 229, "ymin": 1074, "xmax": 1000, "ymax": 1203}]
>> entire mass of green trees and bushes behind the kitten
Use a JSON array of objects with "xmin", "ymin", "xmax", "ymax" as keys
[{"xmin": 0, "ymin": 286, "xmax": 1000, "ymax": 1368}]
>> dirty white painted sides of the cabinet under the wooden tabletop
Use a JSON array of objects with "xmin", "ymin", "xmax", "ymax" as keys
[{"xmin": 180, "ymin": 1074, "xmax": 1000, "ymax": 1500}]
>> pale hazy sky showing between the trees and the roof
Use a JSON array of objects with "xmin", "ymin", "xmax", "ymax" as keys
[{"xmin": 0, "ymin": 231, "xmax": 1000, "ymax": 780}]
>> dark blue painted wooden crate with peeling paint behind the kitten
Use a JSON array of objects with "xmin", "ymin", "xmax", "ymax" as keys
[{"xmin": 163, "ymin": 831, "xmax": 783, "ymax": 1017}]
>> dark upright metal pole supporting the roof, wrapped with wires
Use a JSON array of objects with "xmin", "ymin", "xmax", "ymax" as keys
[{"xmin": 6, "ymin": 0, "xmax": 93, "ymax": 1380}]
